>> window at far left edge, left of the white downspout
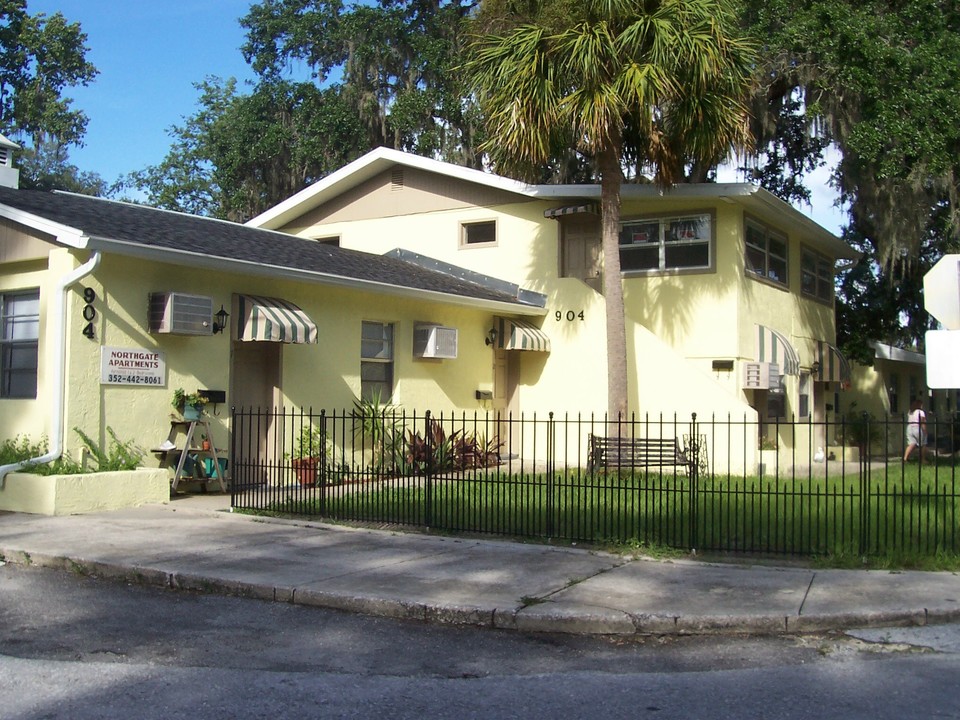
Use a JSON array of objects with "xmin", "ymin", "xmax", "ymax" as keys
[{"xmin": 0, "ymin": 290, "xmax": 40, "ymax": 398}]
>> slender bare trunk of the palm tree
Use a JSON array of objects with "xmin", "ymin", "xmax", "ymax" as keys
[{"xmin": 600, "ymin": 143, "xmax": 628, "ymax": 436}]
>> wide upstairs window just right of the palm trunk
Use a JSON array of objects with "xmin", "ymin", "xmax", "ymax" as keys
[{"xmin": 620, "ymin": 215, "xmax": 712, "ymax": 272}]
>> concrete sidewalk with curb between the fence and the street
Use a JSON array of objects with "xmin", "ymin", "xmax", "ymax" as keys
[{"xmin": 0, "ymin": 495, "xmax": 960, "ymax": 635}]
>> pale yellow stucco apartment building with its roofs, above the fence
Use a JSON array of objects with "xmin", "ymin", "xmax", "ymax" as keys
[{"xmin": 0, "ymin": 148, "xmax": 884, "ymax": 506}]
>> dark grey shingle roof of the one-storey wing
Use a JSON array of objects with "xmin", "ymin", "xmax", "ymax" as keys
[{"xmin": 0, "ymin": 187, "xmax": 529, "ymax": 310}]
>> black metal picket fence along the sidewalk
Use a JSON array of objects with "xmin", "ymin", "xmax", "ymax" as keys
[{"xmin": 231, "ymin": 409, "xmax": 960, "ymax": 555}]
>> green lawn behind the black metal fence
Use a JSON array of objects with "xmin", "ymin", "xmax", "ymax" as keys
[{"xmin": 236, "ymin": 463, "xmax": 960, "ymax": 569}]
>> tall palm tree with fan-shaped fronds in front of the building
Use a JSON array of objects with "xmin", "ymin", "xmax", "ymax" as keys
[{"xmin": 465, "ymin": 0, "xmax": 753, "ymax": 433}]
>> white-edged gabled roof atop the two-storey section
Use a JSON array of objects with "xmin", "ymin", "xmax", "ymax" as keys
[{"xmin": 247, "ymin": 147, "xmax": 860, "ymax": 260}]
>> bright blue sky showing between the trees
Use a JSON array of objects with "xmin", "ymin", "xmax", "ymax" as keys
[{"xmin": 27, "ymin": 0, "xmax": 842, "ymax": 232}]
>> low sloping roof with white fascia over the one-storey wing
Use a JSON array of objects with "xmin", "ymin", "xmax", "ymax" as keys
[{"xmin": 0, "ymin": 187, "xmax": 543, "ymax": 314}]
